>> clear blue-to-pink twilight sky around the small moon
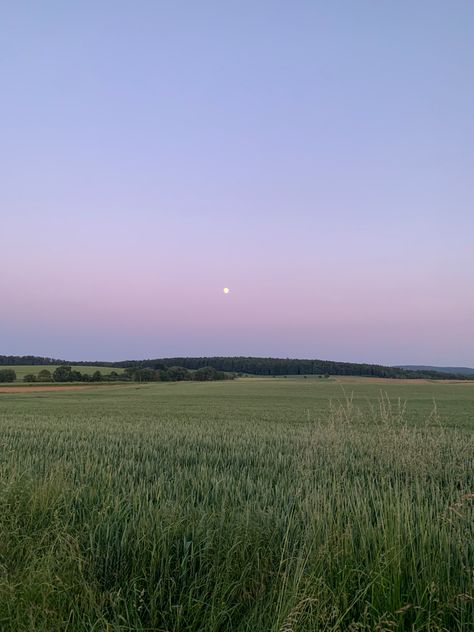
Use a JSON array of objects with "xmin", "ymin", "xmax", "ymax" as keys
[{"xmin": 0, "ymin": 0, "xmax": 474, "ymax": 366}]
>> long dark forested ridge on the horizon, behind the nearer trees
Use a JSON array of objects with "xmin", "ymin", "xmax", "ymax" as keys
[{"xmin": 0, "ymin": 355, "xmax": 474, "ymax": 380}]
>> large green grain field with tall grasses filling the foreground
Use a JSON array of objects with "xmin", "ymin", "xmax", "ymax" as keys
[{"xmin": 0, "ymin": 378, "xmax": 474, "ymax": 632}]
